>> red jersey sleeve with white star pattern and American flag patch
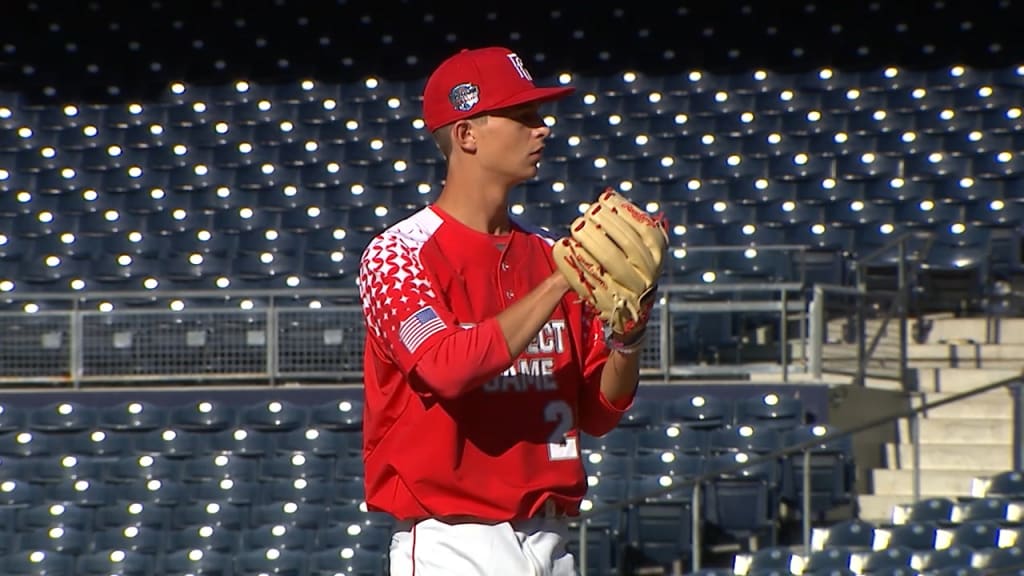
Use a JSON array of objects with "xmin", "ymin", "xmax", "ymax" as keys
[{"xmin": 359, "ymin": 227, "xmax": 511, "ymax": 398}]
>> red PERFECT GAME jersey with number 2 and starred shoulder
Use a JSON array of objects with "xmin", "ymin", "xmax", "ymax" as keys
[{"xmin": 359, "ymin": 206, "xmax": 632, "ymax": 521}]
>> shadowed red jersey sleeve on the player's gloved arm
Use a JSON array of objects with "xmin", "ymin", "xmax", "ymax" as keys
[{"xmin": 580, "ymin": 314, "xmax": 636, "ymax": 436}]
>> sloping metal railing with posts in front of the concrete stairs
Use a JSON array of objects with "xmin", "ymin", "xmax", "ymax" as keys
[{"xmin": 575, "ymin": 368, "xmax": 1024, "ymax": 576}]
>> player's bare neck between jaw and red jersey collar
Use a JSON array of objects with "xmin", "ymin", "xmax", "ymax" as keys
[{"xmin": 434, "ymin": 173, "xmax": 512, "ymax": 235}]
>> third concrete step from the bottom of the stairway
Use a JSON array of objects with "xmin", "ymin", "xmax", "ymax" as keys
[{"xmin": 886, "ymin": 441, "xmax": 1013, "ymax": 470}]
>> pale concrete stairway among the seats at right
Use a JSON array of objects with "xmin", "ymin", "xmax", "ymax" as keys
[{"xmin": 858, "ymin": 318, "xmax": 1024, "ymax": 522}]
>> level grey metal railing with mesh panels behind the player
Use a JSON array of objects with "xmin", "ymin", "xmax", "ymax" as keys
[{"xmin": 0, "ymin": 245, "xmax": 809, "ymax": 387}]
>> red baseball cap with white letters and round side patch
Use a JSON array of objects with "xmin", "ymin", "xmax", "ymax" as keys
[{"xmin": 423, "ymin": 46, "xmax": 575, "ymax": 132}]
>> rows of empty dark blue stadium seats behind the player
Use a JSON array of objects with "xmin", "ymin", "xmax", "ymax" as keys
[{"xmin": 0, "ymin": 0, "xmax": 1024, "ymax": 576}]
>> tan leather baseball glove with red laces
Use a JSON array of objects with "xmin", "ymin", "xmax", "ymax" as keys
[{"xmin": 553, "ymin": 189, "xmax": 669, "ymax": 341}]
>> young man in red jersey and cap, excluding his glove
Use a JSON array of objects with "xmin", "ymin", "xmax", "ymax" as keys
[{"xmin": 359, "ymin": 47, "xmax": 639, "ymax": 576}]
